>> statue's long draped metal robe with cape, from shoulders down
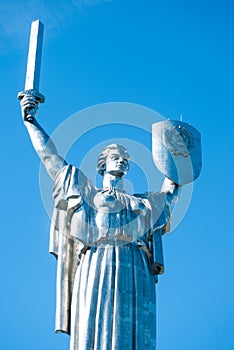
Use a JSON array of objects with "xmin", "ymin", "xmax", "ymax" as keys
[{"xmin": 50, "ymin": 165, "xmax": 170, "ymax": 350}]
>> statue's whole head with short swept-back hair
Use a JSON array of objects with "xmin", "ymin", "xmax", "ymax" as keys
[{"xmin": 97, "ymin": 143, "xmax": 130, "ymax": 177}]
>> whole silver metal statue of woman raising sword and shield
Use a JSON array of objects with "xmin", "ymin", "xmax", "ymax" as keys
[{"xmin": 18, "ymin": 21, "xmax": 201, "ymax": 350}]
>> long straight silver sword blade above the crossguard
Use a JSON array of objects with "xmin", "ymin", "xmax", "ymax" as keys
[{"xmin": 24, "ymin": 20, "xmax": 44, "ymax": 91}]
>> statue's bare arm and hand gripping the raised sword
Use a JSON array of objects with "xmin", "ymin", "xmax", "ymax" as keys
[{"xmin": 20, "ymin": 95, "xmax": 67, "ymax": 180}]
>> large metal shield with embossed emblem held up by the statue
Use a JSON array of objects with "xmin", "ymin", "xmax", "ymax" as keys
[{"xmin": 152, "ymin": 120, "xmax": 202, "ymax": 185}]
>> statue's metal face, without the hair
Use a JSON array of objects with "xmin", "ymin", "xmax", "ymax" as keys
[{"xmin": 105, "ymin": 149, "xmax": 129, "ymax": 177}]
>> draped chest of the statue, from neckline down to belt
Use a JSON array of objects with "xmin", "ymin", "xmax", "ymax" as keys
[{"xmin": 70, "ymin": 191, "xmax": 145, "ymax": 243}]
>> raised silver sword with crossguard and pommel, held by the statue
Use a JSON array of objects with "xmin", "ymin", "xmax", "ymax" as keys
[{"xmin": 17, "ymin": 19, "xmax": 45, "ymax": 121}]
